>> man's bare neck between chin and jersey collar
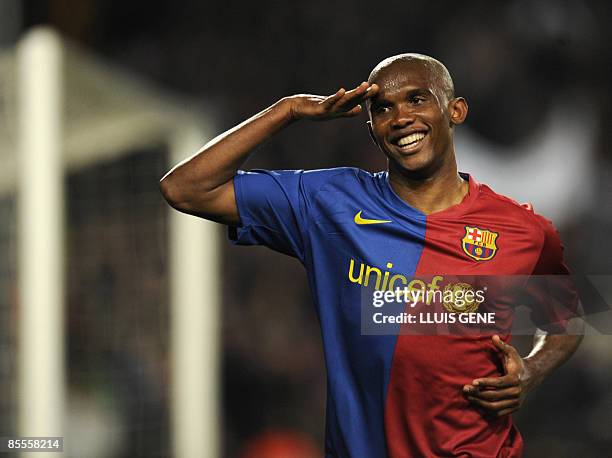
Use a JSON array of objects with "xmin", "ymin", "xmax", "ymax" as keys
[{"xmin": 389, "ymin": 160, "xmax": 469, "ymax": 215}]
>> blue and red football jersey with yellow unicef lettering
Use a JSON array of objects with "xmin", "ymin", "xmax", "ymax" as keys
[{"xmin": 231, "ymin": 168, "xmax": 577, "ymax": 458}]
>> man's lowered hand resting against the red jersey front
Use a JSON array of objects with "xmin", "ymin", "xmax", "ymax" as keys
[{"xmin": 463, "ymin": 335, "xmax": 533, "ymax": 417}]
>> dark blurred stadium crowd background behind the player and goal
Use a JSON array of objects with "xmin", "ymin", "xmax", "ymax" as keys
[{"xmin": 0, "ymin": 0, "xmax": 612, "ymax": 457}]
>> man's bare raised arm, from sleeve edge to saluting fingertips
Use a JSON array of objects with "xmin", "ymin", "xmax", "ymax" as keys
[{"xmin": 160, "ymin": 83, "xmax": 378, "ymax": 225}]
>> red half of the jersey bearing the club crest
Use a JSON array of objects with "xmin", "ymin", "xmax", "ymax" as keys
[{"xmin": 385, "ymin": 179, "xmax": 542, "ymax": 458}]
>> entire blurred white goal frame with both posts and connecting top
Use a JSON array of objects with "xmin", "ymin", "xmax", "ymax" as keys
[{"xmin": 6, "ymin": 28, "xmax": 221, "ymax": 458}]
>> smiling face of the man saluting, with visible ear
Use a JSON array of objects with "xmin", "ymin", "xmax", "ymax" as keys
[{"xmin": 370, "ymin": 61, "xmax": 467, "ymax": 175}]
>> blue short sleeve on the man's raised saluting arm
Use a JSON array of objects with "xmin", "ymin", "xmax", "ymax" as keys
[{"xmin": 229, "ymin": 170, "xmax": 307, "ymax": 260}]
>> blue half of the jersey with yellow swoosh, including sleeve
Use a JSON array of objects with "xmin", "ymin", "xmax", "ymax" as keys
[{"xmin": 234, "ymin": 168, "xmax": 426, "ymax": 457}]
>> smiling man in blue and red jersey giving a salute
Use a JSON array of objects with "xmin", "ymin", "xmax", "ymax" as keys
[{"xmin": 161, "ymin": 54, "xmax": 581, "ymax": 458}]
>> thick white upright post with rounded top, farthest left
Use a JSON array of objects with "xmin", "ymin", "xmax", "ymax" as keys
[{"xmin": 17, "ymin": 29, "xmax": 65, "ymax": 456}]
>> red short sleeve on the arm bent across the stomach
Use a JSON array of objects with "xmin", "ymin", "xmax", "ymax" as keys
[{"xmin": 526, "ymin": 215, "xmax": 581, "ymax": 333}]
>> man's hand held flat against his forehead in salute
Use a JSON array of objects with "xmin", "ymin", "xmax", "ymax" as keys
[{"xmin": 285, "ymin": 82, "xmax": 378, "ymax": 121}]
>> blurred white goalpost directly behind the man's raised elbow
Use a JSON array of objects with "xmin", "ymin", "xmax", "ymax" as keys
[{"xmin": 169, "ymin": 129, "xmax": 220, "ymax": 458}]
